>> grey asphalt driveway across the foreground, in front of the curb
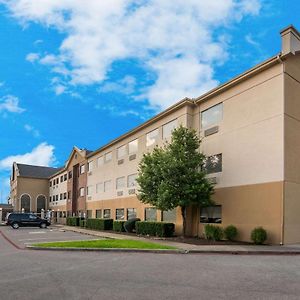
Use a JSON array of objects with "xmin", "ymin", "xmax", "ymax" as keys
[{"xmin": 0, "ymin": 227, "xmax": 300, "ymax": 300}]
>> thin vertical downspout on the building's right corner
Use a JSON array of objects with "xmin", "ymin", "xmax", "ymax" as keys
[{"xmin": 277, "ymin": 55, "xmax": 285, "ymax": 245}]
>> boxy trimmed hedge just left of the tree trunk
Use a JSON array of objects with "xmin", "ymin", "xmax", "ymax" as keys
[{"xmin": 135, "ymin": 221, "xmax": 175, "ymax": 237}]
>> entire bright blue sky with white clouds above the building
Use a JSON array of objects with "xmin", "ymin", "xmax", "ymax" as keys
[{"xmin": 0, "ymin": 0, "xmax": 300, "ymax": 202}]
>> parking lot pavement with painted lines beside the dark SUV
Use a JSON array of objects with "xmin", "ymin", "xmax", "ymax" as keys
[{"xmin": 0, "ymin": 226, "xmax": 99, "ymax": 248}]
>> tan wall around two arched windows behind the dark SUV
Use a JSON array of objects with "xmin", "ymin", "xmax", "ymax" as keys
[{"xmin": 14, "ymin": 177, "xmax": 49, "ymax": 211}]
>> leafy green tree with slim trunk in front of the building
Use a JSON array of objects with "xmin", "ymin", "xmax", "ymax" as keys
[{"xmin": 137, "ymin": 126, "xmax": 214, "ymax": 235}]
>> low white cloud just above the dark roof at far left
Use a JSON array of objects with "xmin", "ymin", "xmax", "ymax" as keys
[{"xmin": 0, "ymin": 142, "xmax": 55, "ymax": 170}]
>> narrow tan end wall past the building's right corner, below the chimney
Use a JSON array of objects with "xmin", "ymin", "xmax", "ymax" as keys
[{"xmin": 284, "ymin": 55, "xmax": 300, "ymax": 244}]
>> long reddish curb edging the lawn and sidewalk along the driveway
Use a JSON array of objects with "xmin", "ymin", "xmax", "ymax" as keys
[{"xmin": 26, "ymin": 245, "xmax": 300, "ymax": 256}]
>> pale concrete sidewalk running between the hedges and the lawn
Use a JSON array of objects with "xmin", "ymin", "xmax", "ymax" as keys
[{"xmin": 61, "ymin": 226, "xmax": 300, "ymax": 255}]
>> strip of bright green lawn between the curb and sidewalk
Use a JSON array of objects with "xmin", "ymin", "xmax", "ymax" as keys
[{"xmin": 32, "ymin": 239, "xmax": 177, "ymax": 250}]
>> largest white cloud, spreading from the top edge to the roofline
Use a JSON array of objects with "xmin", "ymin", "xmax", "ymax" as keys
[{"xmin": 4, "ymin": 0, "xmax": 261, "ymax": 108}]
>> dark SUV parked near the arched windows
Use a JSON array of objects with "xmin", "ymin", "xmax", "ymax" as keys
[{"xmin": 6, "ymin": 213, "xmax": 50, "ymax": 229}]
